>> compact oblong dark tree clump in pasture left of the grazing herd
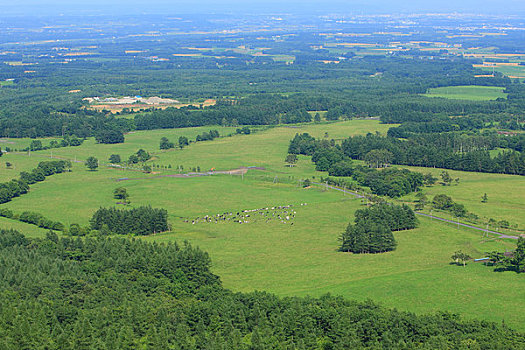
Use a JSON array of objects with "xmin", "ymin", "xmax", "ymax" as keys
[{"xmin": 90, "ymin": 206, "xmax": 169, "ymax": 235}]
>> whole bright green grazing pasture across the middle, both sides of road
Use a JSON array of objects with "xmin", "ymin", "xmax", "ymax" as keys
[{"xmin": 0, "ymin": 120, "xmax": 525, "ymax": 330}]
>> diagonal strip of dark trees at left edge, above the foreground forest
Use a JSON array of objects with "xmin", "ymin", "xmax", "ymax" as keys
[{"xmin": 0, "ymin": 160, "xmax": 71, "ymax": 204}]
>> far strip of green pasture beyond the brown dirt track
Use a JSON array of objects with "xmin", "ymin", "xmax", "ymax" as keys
[{"xmin": 9, "ymin": 120, "xmax": 392, "ymax": 176}]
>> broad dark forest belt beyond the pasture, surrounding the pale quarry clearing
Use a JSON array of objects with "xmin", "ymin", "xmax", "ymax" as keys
[{"xmin": 0, "ymin": 53, "xmax": 525, "ymax": 143}]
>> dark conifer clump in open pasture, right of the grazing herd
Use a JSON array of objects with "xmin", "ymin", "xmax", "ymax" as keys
[{"xmin": 339, "ymin": 203, "xmax": 418, "ymax": 254}]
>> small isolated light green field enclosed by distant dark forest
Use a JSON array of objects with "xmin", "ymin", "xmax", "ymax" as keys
[{"xmin": 424, "ymin": 85, "xmax": 507, "ymax": 101}]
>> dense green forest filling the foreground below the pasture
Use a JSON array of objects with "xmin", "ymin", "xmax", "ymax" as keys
[{"xmin": 0, "ymin": 230, "xmax": 525, "ymax": 350}]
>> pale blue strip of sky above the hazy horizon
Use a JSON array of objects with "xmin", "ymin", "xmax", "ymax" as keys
[{"xmin": 0, "ymin": 0, "xmax": 525, "ymax": 15}]
